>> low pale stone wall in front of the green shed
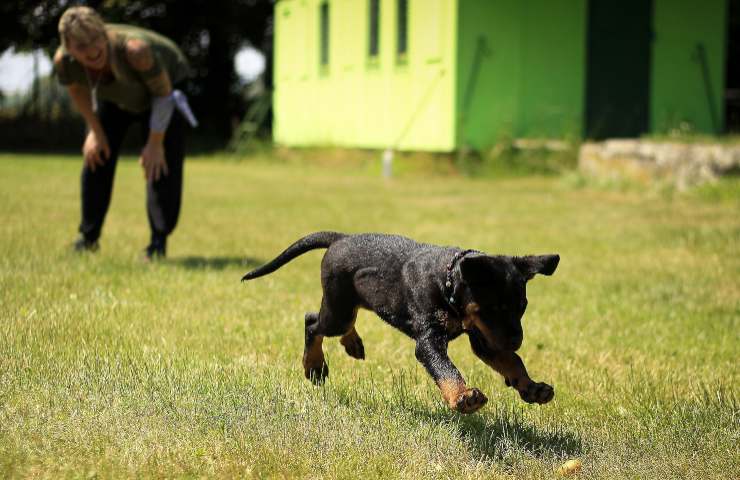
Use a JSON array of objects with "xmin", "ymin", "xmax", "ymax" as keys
[{"xmin": 578, "ymin": 140, "xmax": 740, "ymax": 189}]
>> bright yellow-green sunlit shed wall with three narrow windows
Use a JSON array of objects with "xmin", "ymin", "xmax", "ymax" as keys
[{"xmin": 274, "ymin": 0, "xmax": 457, "ymax": 151}]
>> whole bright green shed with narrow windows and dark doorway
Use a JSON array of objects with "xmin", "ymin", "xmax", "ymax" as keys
[{"xmin": 273, "ymin": 0, "xmax": 737, "ymax": 152}]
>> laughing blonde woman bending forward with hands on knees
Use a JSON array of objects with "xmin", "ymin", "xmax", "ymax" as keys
[{"xmin": 54, "ymin": 7, "xmax": 196, "ymax": 260}]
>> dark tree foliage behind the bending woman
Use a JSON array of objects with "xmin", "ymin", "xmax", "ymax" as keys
[{"xmin": 0, "ymin": 0, "xmax": 274, "ymax": 145}]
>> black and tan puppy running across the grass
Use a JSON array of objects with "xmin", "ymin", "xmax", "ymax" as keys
[{"xmin": 242, "ymin": 232, "xmax": 560, "ymax": 413}]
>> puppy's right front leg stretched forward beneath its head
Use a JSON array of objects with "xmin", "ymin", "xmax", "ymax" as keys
[{"xmin": 471, "ymin": 341, "xmax": 555, "ymax": 404}]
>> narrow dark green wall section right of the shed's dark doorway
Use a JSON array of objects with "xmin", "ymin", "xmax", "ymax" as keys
[{"xmin": 650, "ymin": 0, "xmax": 727, "ymax": 133}]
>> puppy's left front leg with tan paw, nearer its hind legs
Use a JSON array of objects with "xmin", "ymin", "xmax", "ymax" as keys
[{"xmin": 416, "ymin": 334, "xmax": 488, "ymax": 413}]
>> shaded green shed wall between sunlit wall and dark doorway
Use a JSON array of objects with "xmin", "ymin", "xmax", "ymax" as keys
[{"xmin": 456, "ymin": 0, "xmax": 586, "ymax": 149}]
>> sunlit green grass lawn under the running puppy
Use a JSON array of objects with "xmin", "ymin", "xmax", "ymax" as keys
[{"xmin": 0, "ymin": 154, "xmax": 740, "ymax": 479}]
